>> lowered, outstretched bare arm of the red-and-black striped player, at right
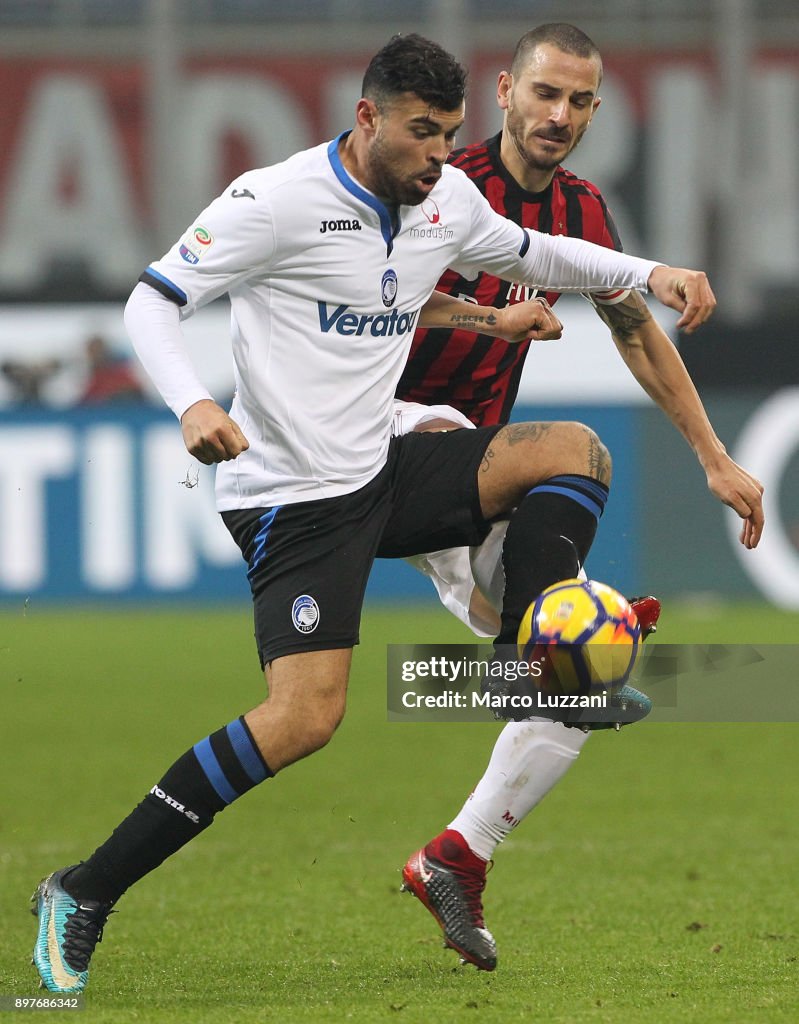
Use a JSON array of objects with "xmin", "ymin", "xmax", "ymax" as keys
[{"xmin": 595, "ymin": 292, "xmax": 763, "ymax": 548}]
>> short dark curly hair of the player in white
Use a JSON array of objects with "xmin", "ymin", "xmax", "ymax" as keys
[{"xmin": 362, "ymin": 33, "xmax": 466, "ymax": 111}]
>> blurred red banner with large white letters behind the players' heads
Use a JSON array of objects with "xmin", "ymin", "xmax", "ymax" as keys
[{"xmin": 0, "ymin": 48, "xmax": 799, "ymax": 299}]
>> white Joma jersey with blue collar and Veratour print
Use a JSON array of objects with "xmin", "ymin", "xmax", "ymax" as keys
[{"xmin": 134, "ymin": 136, "xmax": 657, "ymax": 510}]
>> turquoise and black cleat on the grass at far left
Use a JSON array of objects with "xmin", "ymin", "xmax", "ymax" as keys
[{"xmin": 31, "ymin": 865, "xmax": 112, "ymax": 992}]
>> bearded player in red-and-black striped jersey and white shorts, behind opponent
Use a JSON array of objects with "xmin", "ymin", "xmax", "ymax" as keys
[{"xmin": 395, "ymin": 25, "xmax": 763, "ymax": 971}]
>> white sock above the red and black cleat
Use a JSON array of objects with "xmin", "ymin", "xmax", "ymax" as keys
[{"xmin": 449, "ymin": 721, "xmax": 589, "ymax": 860}]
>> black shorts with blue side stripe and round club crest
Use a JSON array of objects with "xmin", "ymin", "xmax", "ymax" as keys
[{"xmin": 222, "ymin": 427, "xmax": 501, "ymax": 666}]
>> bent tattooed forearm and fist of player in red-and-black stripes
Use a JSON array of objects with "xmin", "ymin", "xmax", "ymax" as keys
[{"xmin": 419, "ymin": 292, "xmax": 563, "ymax": 344}]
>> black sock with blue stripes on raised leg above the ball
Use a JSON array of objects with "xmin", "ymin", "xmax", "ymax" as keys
[{"xmin": 496, "ymin": 474, "xmax": 608, "ymax": 649}]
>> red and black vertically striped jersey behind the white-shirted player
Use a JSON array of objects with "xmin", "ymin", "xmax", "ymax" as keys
[{"xmin": 396, "ymin": 135, "xmax": 622, "ymax": 426}]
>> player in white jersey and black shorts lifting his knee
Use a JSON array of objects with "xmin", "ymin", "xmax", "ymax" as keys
[{"xmin": 34, "ymin": 35, "xmax": 715, "ymax": 992}]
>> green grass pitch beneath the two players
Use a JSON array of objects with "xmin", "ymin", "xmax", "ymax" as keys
[{"xmin": 0, "ymin": 603, "xmax": 799, "ymax": 1024}]
